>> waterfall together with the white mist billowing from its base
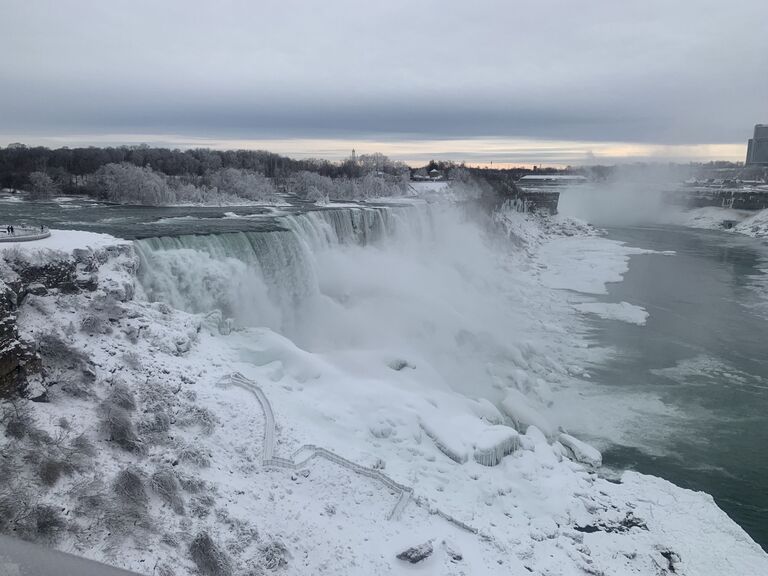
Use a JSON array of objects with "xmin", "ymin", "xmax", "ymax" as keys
[{"xmin": 136, "ymin": 203, "xmax": 575, "ymax": 408}]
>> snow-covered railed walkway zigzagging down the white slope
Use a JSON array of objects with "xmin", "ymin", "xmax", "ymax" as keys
[{"xmin": 218, "ymin": 372, "xmax": 479, "ymax": 534}]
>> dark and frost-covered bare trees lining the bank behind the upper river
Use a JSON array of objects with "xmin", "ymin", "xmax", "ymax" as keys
[{"xmin": 0, "ymin": 144, "xmax": 410, "ymax": 205}]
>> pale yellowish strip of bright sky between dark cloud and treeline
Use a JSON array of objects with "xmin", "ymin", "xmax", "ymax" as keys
[{"xmin": 0, "ymin": 133, "xmax": 746, "ymax": 169}]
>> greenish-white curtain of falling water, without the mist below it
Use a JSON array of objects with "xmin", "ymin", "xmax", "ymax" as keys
[{"xmin": 136, "ymin": 205, "xmax": 431, "ymax": 334}]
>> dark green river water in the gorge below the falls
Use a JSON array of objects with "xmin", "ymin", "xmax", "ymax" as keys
[{"xmin": 592, "ymin": 226, "xmax": 768, "ymax": 549}]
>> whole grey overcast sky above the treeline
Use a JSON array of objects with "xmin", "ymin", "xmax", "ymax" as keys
[{"xmin": 0, "ymin": 0, "xmax": 768, "ymax": 163}]
